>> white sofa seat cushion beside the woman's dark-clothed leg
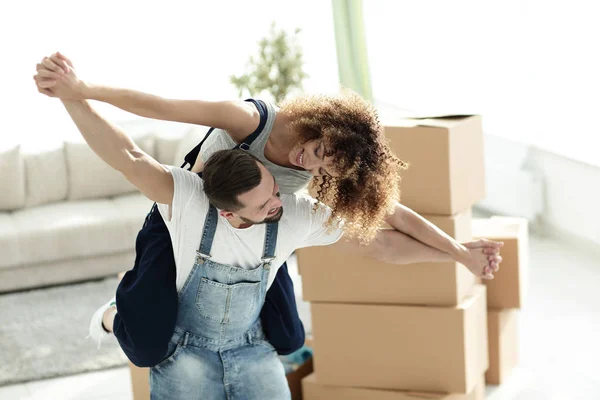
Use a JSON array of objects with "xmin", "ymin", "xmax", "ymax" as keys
[{"xmin": 12, "ymin": 199, "xmax": 139, "ymax": 264}]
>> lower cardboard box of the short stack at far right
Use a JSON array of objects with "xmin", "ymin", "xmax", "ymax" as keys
[{"xmin": 485, "ymin": 309, "xmax": 519, "ymax": 385}]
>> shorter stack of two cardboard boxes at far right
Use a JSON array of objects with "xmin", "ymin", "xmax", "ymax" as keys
[{"xmin": 473, "ymin": 217, "xmax": 529, "ymax": 385}]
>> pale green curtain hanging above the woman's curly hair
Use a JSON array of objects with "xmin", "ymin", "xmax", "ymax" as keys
[{"xmin": 332, "ymin": 0, "xmax": 373, "ymax": 101}]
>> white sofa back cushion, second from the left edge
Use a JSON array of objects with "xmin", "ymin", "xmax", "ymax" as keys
[{"xmin": 23, "ymin": 142, "xmax": 68, "ymax": 207}]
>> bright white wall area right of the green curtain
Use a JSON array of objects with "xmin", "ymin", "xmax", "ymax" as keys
[{"xmin": 363, "ymin": 0, "xmax": 600, "ymax": 166}]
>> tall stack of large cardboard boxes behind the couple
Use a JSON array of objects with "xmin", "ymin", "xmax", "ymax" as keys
[{"xmin": 297, "ymin": 116, "xmax": 488, "ymax": 400}]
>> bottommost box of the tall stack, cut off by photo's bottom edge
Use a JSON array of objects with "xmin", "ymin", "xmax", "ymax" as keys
[{"xmin": 302, "ymin": 374, "xmax": 485, "ymax": 400}]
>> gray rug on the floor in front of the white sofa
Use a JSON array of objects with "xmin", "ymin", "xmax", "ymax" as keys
[{"xmin": 0, "ymin": 278, "xmax": 127, "ymax": 386}]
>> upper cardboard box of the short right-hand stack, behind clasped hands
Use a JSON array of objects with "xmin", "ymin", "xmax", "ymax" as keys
[{"xmin": 473, "ymin": 217, "xmax": 529, "ymax": 309}]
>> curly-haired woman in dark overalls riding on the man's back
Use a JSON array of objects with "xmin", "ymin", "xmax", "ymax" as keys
[{"xmin": 35, "ymin": 53, "xmax": 498, "ymax": 366}]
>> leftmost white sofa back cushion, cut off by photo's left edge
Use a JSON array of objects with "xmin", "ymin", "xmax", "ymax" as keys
[{"xmin": 0, "ymin": 145, "xmax": 25, "ymax": 211}]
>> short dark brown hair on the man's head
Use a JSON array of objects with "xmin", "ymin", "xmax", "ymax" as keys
[{"xmin": 202, "ymin": 149, "xmax": 261, "ymax": 211}]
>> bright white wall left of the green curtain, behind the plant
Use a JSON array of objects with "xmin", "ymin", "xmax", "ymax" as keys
[{"xmin": 0, "ymin": 0, "xmax": 338, "ymax": 148}]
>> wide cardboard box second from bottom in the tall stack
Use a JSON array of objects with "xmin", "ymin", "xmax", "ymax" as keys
[{"xmin": 311, "ymin": 285, "xmax": 488, "ymax": 393}]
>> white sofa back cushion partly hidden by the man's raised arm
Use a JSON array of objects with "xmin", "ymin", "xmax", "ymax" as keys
[{"xmin": 65, "ymin": 135, "xmax": 155, "ymax": 200}]
